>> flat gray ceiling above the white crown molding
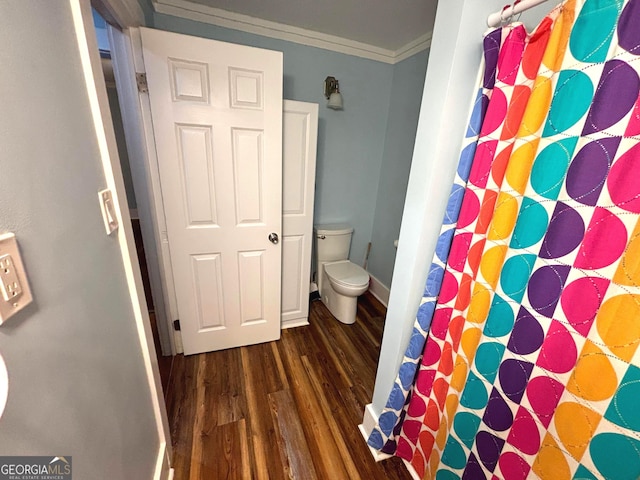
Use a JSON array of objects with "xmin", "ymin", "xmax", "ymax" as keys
[{"xmin": 154, "ymin": 0, "xmax": 437, "ymax": 52}]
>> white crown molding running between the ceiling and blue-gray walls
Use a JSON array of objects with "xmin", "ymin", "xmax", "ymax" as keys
[{"xmin": 151, "ymin": 0, "xmax": 431, "ymax": 64}]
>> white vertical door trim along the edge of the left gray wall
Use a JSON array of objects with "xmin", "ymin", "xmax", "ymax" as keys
[{"xmin": 76, "ymin": 0, "xmax": 173, "ymax": 474}]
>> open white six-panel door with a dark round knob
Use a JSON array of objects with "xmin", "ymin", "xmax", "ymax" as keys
[{"xmin": 140, "ymin": 28, "xmax": 282, "ymax": 354}]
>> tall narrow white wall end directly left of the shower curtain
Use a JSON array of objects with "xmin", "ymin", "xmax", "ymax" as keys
[{"xmin": 372, "ymin": 0, "xmax": 554, "ymax": 415}]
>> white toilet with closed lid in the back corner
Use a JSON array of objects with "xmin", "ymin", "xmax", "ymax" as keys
[{"xmin": 314, "ymin": 224, "xmax": 369, "ymax": 324}]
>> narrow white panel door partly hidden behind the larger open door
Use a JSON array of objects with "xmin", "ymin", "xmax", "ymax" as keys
[{"xmin": 282, "ymin": 100, "xmax": 318, "ymax": 328}]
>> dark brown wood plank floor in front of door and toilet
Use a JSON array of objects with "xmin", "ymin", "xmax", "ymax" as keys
[{"xmin": 167, "ymin": 293, "xmax": 411, "ymax": 480}]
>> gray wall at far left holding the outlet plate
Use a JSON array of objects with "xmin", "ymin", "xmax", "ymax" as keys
[{"xmin": 0, "ymin": 0, "xmax": 164, "ymax": 480}]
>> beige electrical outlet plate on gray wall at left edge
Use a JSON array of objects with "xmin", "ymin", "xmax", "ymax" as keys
[{"xmin": 0, "ymin": 233, "xmax": 33, "ymax": 325}]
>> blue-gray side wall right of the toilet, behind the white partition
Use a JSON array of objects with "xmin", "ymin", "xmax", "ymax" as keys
[{"xmin": 367, "ymin": 50, "xmax": 429, "ymax": 287}]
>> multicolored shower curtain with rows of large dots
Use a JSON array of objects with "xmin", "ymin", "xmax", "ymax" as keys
[{"xmin": 369, "ymin": 0, "xmax": 640, "ymax": 480}]
